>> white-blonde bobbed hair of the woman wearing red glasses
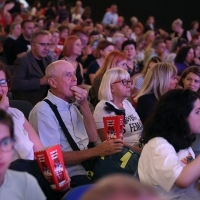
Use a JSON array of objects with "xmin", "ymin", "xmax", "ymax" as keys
[{"xmin": 98, "ymin": 68, "xmax": 130, "ymax": 101}]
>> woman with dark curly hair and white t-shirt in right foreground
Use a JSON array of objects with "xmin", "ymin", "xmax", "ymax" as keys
[{"xmin": 138, "ymin": 89, "xmax": 200, "ymax": 200}]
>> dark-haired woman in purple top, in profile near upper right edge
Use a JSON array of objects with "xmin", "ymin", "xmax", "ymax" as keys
[{"xmin": 174, "ymin": 46, "xmax": 194, "ymax": 76}]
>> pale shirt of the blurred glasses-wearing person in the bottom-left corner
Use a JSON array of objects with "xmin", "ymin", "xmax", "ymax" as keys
[{"xmin": 0, "ymin": 170, "xmax": 46, "ymax": 200}]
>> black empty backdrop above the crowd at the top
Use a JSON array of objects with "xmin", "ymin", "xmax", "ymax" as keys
[{"xmin": 27, "ymin": 0, "xmax": 200, "ymax": 31}]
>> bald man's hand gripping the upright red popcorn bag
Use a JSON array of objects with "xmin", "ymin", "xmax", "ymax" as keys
[{"xmin": 97, "ymin": 139, "xmax": 123, "ymax": 156}]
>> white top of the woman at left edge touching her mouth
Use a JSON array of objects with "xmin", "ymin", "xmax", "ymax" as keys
[{"xmin": 7, "ymin": 107, "xmax": 34, "ymax": 160}]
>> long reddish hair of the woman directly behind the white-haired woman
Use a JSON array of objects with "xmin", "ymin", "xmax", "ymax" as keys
[{"xmin": 95, "ymin": 51, "xmax": 127, "ymax": 78}]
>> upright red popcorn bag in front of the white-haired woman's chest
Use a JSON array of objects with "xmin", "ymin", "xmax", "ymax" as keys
[{"xmin": 103, "ymin": 115, "xmax": 124, "ymax": 140}]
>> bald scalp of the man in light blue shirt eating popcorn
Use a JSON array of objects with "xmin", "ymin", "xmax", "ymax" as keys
[{"xmin": 45, "ymin": 60, "xmax": 74, "ymax": 79}]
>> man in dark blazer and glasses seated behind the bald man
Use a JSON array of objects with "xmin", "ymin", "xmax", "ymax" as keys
[{"xmin": 12, "ymin": 31, "xmax": 51, "ymax": 105}]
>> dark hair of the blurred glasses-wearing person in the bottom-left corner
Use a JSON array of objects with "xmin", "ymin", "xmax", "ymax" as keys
[{"xmin": 0, "ymin": 109, "xmax": 14, "ymax": 139}]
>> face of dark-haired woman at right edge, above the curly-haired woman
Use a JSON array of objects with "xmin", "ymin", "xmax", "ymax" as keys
[{"xmin": 182, "ymin": 72, "xmax": 200, "ymax": 92}]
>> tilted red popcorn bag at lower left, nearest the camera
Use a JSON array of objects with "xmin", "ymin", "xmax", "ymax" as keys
[{"xmin": 35, "ymin": 145, "xmax": 70, "ymax": 191}]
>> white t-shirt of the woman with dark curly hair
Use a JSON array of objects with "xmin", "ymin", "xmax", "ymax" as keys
[{"xmin": 138, "ymin": 137, "xmax": 200, "ymax": 200}]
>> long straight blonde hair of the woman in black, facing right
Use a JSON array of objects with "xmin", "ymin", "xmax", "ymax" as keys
[{"xmin": 134, "ymin": 62, "xmax": 177, "ymax": 102}]
